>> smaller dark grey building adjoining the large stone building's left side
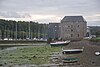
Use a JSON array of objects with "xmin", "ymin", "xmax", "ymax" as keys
[{"xmin": 47, "ymin": 23, "xmax": 60, "ymax": 39}]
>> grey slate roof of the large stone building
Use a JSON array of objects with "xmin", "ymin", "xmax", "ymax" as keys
[{"xmin": 62, "ymin": 16, "xmax": 85, "ymax": 22}]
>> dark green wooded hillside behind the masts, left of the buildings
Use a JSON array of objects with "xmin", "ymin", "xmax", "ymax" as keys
[{"xmin": 0, "ymin": 19, "xmax": 48, "ymax": 39}]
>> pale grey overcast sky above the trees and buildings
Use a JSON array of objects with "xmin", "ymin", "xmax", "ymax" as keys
[{"xmin": 0, "ymin": 0, "xmax": 100, "ymax": 25}]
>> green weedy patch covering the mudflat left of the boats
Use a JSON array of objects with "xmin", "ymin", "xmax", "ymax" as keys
[{"xmin": 0, "ymin": 46, "xmax": 61, "ymax": 65}]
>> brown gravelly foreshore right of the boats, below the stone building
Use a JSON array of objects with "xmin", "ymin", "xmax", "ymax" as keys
[{"xmin": 64, "ymin": 40, "xmax": 100, "ymax": 67}]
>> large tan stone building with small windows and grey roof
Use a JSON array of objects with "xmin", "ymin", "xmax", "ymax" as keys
[{"xmin": 61, "ymin": 16, "xmax": 87, "ymax": 40}]
